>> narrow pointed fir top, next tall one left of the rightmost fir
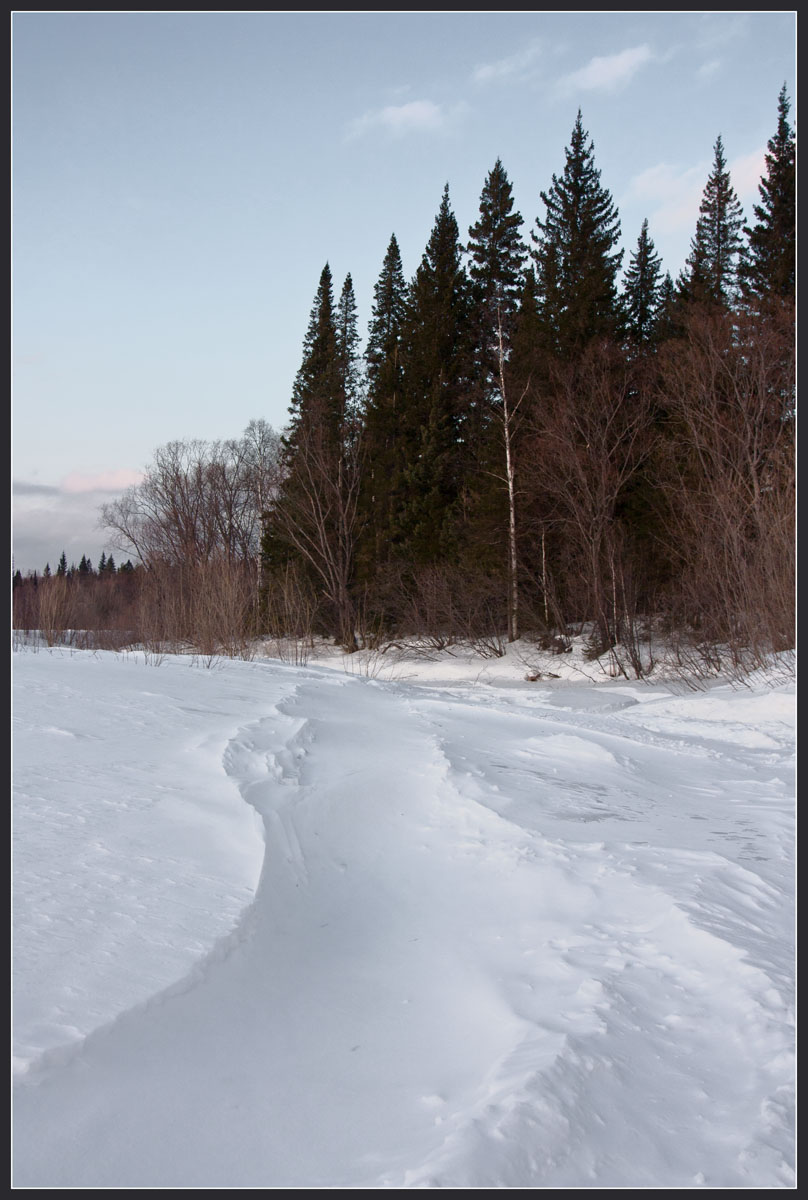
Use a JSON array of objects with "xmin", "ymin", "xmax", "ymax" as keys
[{"xmin": 678, "ymin": 134, "xmax": 743, "ymax": 308}]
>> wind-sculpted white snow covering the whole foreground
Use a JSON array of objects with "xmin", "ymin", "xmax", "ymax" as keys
[{"xmin": 13, "ymin": 648, "xmax": 795, "ymax": 1188}]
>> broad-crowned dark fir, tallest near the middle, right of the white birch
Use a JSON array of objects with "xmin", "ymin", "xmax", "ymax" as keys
[{"xmin": 531, "ymin": 109, "xmax": 623, "ymax": 360}]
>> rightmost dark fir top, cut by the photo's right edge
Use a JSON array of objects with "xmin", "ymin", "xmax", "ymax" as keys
[{"xmin": 741, "ymin": 84, "xmax": 796, "ymax": 304}]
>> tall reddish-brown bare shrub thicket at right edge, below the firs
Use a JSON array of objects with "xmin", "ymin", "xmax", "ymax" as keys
[{"xmin": 663, "ymin": 307, "xmax": 796, "ymax": 673}]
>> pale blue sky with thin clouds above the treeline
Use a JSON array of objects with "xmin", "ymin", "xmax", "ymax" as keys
[{"xmin": 12, "ymin": 11, "xmax": 796, "ymax": 572}]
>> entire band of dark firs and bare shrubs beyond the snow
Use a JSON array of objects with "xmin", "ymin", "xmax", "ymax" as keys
[{"xmin": 13, "ymin": 86, "xmax": 796, "ymax": 676}]
